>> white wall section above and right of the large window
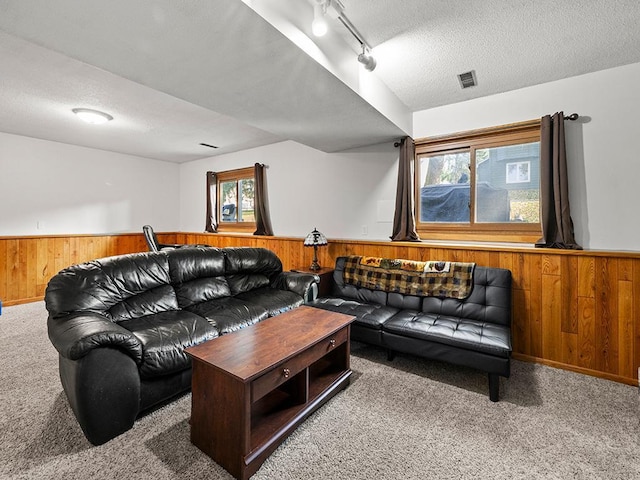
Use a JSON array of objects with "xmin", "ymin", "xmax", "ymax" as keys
[{"xmin": 413, "ymin": 63, "xmax": 640, "ymax": 251}]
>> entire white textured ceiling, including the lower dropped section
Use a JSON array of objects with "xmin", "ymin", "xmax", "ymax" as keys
[{"xmin": 0, "ymin": 0, "xmax": 640, "ymax": 162}]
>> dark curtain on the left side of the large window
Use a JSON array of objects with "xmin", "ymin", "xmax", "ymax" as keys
[{"xmin": 390, "ymin": 137, "xmax": 420, "ymax": 242}]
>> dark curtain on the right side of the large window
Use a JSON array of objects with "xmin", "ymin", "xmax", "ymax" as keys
[{"xmin": 536, "ymin": 112, "xmax": 582, "ymax": 250}]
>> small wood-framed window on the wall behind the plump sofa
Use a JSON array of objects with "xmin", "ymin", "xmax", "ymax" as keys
[{"xmin": 216, "ymin": 167, "xmax": 256, "ymax": 231}]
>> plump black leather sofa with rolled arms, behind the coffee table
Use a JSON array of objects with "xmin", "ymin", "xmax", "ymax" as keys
[{"xmin": 45, "ymin": 247, "xmax": 318, "ymax": 445}]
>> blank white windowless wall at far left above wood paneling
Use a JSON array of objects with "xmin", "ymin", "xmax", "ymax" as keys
[{"xmin": 0, "ymin": 133, "xmax": 179, "ymax": 236}]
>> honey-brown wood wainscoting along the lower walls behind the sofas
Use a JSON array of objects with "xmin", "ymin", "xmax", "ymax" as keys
[{"xmin": 0, "ymin": 233, "xmax": 640, "ymax": 385}]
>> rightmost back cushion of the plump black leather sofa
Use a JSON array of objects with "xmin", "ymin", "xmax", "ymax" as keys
[{"xmin": 223, "ymin": 247, "xmax": 282, "ymax": 295}]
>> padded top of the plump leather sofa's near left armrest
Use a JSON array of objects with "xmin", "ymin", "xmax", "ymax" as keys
[{"xmin": 47, "ymin": 313, "xmax": 142, "ymax": 364}]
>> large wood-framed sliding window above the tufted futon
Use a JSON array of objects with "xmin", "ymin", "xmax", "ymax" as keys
[{"xmin": 415, "ymin": 121, "xmax": 541, "ymax": 242}]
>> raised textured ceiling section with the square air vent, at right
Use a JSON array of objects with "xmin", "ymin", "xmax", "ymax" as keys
[{"xmin": 345, "ymin": 0, "xmax": 640, "ymax": 112}]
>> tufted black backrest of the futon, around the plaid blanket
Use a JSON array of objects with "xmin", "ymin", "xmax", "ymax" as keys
[{"xmin": 332, "ymin": 257, "xmax": 511, "ymax": 325}]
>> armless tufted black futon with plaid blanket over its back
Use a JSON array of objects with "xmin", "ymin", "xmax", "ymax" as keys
[{"xmin": 312, "ymin": 257, "xmax": 511, "ymax": 402}]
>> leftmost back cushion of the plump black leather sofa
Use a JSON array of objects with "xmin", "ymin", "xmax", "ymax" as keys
[{"xmin": 45, "ymin": 252, "xmax": 178, "ymax": 322}]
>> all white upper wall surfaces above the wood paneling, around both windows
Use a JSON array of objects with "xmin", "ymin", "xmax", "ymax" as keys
[{"xmin": 5, "ymin": 63, "xmax": 640, "ymax": 251}]
